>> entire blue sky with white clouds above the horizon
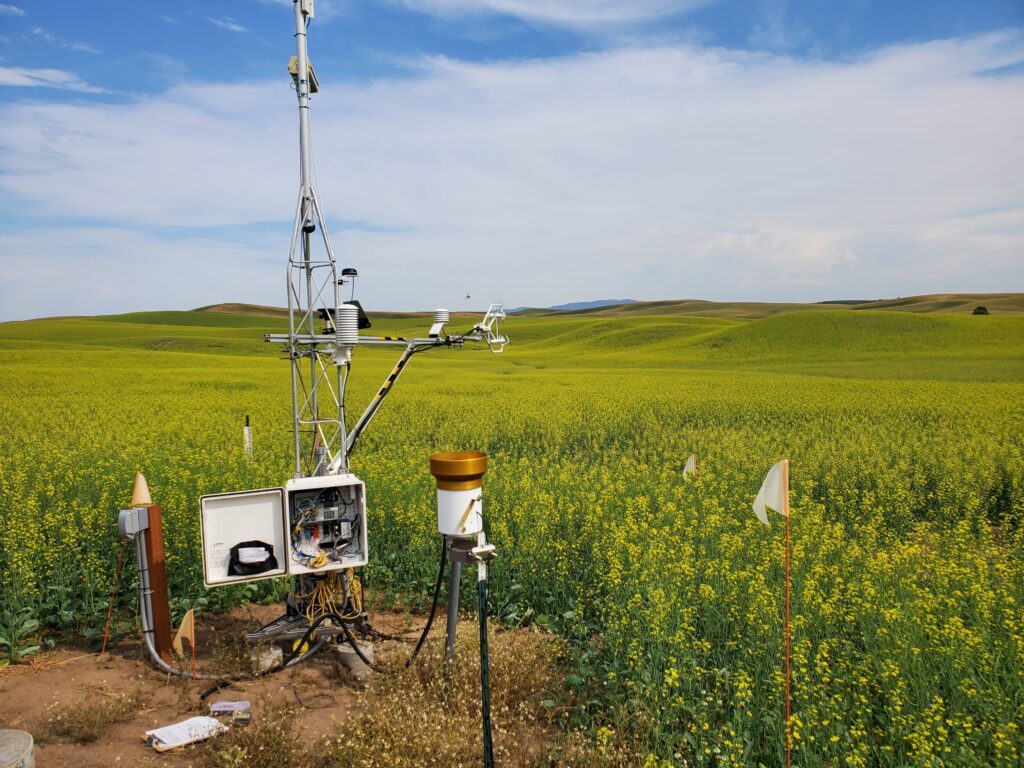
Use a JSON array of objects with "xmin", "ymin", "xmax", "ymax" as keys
[{"xmin": 0, "ymin": 0, "xmax": 1024, "ymax": 321}]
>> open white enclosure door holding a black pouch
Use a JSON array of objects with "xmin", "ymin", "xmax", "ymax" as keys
[{"xmin": 200, "ymin": 488, "xmax": 288, "ymax": 587}]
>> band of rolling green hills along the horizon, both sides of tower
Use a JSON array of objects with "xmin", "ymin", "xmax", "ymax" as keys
[{"xmin": 0, "ymin": 302, "xmax": 1024, "ymax": 381}]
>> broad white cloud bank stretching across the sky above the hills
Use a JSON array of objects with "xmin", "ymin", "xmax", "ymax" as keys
[{"xmin": 0, "ymin": 35, "xmax": 1024, "ymax": 313}]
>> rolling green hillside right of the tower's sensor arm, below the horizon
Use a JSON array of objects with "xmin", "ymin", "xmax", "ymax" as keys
[{"xmin": 508, "ymin": 308, "xmax": 1024, "ymax": 381}]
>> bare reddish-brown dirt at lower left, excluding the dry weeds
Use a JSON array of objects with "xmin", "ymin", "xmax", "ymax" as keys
[{"xmin": 0, "ymin": 605, "xmax": 430, "ymax": 768}]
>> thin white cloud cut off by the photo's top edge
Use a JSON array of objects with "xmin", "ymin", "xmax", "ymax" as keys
[{"xmin": 392, "ymin": 0, "xmax": 713, "ymax": 26}]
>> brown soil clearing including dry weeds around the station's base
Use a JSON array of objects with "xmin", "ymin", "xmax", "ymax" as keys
[{"xmin": 0, "ymin": 605, "xmax": 569, "ymax": 768}]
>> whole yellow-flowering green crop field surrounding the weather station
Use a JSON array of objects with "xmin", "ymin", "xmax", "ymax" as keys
[{"xmin": 0, "ymin": 309, "xmax": 1024, "ymax": 767}]
